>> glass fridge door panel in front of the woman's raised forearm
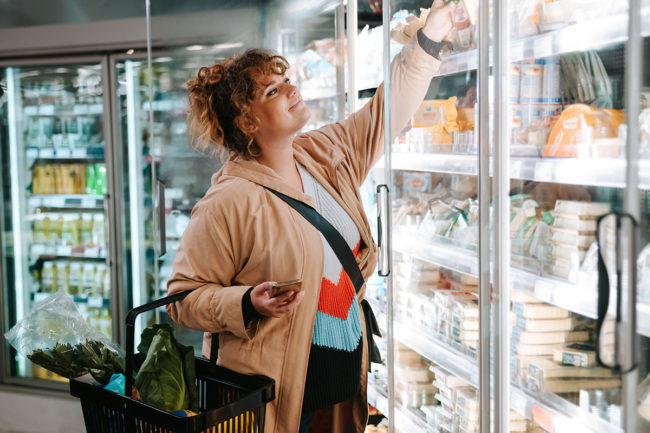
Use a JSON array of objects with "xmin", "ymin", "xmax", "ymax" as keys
[{"xmin": 374, "ymin": 1, "xmax": 490, "ymax": 433}]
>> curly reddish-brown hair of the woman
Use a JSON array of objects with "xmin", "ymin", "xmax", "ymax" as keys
[{"xmin": 187, "ymin": 48, "xmax": 289, "ymax": 159}]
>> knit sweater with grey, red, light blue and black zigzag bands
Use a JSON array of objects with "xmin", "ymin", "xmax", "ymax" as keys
[{"xmin": 298, "ymin": 165, "xmax": 363, "ymax": 411}]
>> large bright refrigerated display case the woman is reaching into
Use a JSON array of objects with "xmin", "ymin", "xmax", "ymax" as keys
[{"xmin": 369, "ymin": 0, "xmax": 650, "ymax": 432}]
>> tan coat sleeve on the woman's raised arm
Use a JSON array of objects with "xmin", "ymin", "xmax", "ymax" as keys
[{"xmin": 296, "ymin": 37, "xmax": 440, "ymax": 187}]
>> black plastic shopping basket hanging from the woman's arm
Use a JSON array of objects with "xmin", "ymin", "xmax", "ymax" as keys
[{"xmin": 70, "ymin": 292, "xmax": 275, "ymax": 433}]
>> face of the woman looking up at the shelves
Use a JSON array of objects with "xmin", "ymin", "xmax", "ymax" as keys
[{"xmin": 250, "ymin": 74, "xmax": 311, "ymax": 143}]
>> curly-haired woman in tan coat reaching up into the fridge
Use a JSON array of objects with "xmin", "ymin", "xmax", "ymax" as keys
[{"xmin": 167, "ymin": 0, "xmax": 453, "ymax": 433}]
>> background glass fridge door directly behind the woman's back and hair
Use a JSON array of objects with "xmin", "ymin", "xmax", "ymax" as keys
[{"xmin": 114, "ymin": 49, "xmax": 225, "ymax": 354}]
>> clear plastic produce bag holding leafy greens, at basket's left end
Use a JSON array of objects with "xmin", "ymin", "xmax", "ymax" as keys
[{"xmin": 5, "ymin": 291, "xmax": 124, "ymax": 385}]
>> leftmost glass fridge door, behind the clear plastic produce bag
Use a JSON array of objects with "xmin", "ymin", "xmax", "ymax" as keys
[{"xmin": 0, "ymin": 58, "xmax": 116, "ymax": 380}]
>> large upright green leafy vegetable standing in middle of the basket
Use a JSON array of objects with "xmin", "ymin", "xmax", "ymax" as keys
[{"xmin": 135, "ymin": 324, "xmax": 199, "ymax": 412}]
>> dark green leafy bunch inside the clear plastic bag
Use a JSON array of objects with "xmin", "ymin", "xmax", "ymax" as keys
[{"xmin": 27, "ymin": 340, "xmax": 124, "ymax": 385}]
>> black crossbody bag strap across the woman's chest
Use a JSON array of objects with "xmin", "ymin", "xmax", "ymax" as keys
[{"xmin": 264, "ymin": 187, "xmax": 364, "ymax": 293}]
